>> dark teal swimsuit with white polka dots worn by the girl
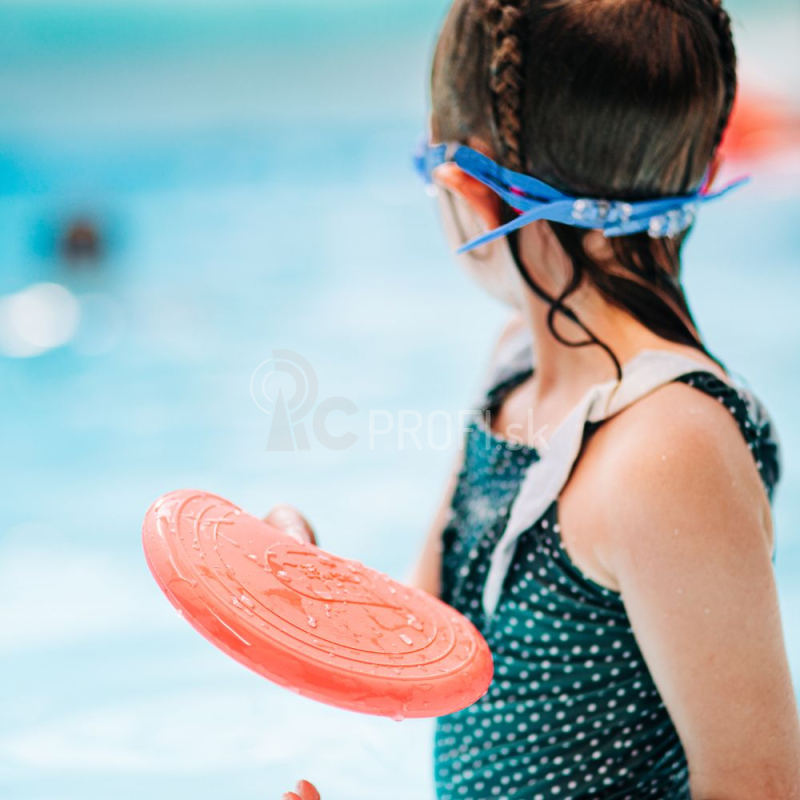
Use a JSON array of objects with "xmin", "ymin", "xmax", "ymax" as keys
[{"xmin": 434, "ymin": 368, "xmax": 779, "ymax": 800}]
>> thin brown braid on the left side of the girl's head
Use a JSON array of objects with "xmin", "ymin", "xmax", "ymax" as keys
[{"xmin": 484, "ymin": 0, "xmax": 528, "ymax": 172}]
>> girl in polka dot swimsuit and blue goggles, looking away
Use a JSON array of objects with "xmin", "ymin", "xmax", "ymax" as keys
[{"xmin": 282, "ymin": 0, "xmax": 800, "ymax": 800}]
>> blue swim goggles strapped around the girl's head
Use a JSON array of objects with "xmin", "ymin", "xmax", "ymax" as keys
[{"xmin": 414, "ymin": 134, "xmax": 750, "ymax": 253}]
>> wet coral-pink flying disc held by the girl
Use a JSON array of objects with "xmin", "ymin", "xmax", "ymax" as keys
[{"xmin": 142, "ymin": 491, "xmax": 492, "ymax": 719}]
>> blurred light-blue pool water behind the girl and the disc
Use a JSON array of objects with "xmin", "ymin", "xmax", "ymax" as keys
[{"xmin": 0, "ymin": 4, "xmax": 800, "ymax": 800}]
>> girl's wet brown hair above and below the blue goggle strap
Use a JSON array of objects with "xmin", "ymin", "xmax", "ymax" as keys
[{"xmin": 431, "ymin": 0, "xmax": 736, "ymax": 366}]
